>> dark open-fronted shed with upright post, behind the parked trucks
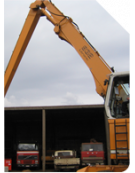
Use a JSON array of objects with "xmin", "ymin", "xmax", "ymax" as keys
[{"xmin": 4, "ymin": 105, "xmax": 108, "ymax": 171}]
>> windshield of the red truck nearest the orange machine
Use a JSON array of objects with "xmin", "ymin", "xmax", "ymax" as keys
[{"xmin": 82, "ymin": 144, "xmax": 103, "ymax": 151}]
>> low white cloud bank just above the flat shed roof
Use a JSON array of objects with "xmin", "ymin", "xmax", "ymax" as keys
[{"xmin": 4, "ymin": 92, "xmax": 104, "ymax": 107}]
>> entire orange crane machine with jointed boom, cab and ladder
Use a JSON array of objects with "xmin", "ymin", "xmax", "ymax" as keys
[{"xmin": 4, "ymin": 0, "xmax": 130, "ymax": 172}]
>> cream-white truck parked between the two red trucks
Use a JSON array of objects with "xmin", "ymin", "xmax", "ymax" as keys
[{"xmin": 54, "ymin": 150, "xmax": 80, "ymax": 170}]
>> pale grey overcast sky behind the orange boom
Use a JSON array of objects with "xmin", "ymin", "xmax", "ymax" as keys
[{"xmin": 4, "ymin": 0, "xmax": 130, "ymax": 107}]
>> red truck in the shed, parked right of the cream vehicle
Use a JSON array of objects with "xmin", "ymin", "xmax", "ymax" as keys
[{"xmin": 81, "ymin": 142, "xmax": 105, "ymax": 166}]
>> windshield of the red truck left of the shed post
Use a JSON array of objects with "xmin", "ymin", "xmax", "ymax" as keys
[{"xmin": 18, "ymin": 144, "xmax": 38, "ymax": 151}]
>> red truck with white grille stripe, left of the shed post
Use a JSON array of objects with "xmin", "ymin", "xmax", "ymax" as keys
[{"xmin": 16, "ymin": 143, "xmax": 39, "ymax": 168}]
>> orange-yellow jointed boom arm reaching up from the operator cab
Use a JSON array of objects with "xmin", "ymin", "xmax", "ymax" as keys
[{"xmin": 4, "ymin": 0, "xmax": 112, "ymax": 97}]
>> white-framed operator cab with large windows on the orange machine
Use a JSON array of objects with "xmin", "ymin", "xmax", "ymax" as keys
[{"xmin": 105, "ymin": 71, "xmax": 130, "ymax": 118}]
